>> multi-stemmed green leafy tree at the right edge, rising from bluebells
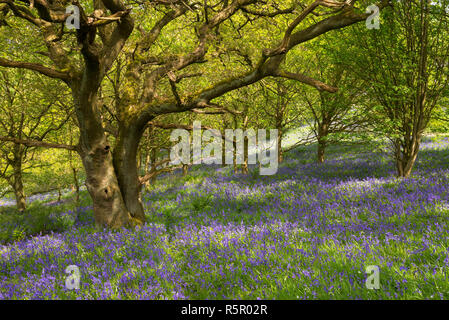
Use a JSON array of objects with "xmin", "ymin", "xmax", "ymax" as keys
[{"xmin": 341, "ymin": 0, "xmax": 449, "ymax": 177}]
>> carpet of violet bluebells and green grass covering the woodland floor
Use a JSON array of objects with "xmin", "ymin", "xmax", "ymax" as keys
[{"xmin": 0, "ymin": 137, "xmax": 449, "ymax": 299}]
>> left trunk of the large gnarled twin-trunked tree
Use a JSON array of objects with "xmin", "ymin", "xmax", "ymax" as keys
[{"xmin": 72, "ymin": 81, "xmax": 136, "ymax": 229}]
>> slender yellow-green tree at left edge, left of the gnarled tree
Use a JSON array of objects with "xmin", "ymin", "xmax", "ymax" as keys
[{"xmin": 0, "ymin": 70, "xmax": 70, "ymax": 211}]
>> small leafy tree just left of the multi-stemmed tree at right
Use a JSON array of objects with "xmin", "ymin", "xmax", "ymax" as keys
[{"xmin": 300, "ymin": 37, "xmax": 371, "ymax": 163}]
